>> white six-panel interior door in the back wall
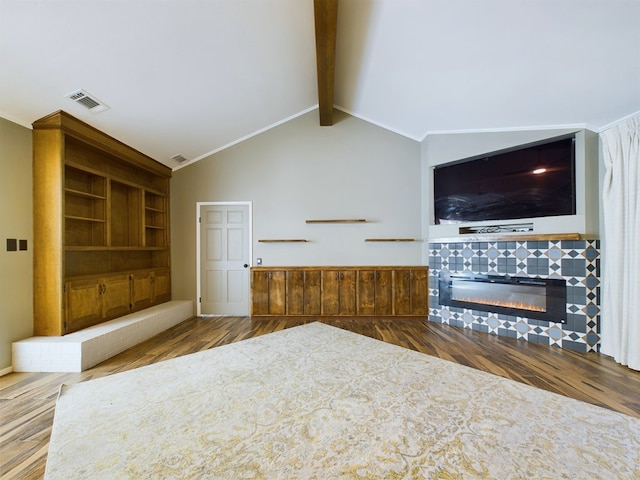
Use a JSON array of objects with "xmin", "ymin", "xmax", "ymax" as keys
[{"xmin": 199, "ymin": 203, "xmax": 251, "ymax": 316}]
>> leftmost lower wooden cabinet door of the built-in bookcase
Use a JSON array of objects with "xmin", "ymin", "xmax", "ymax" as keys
[{"xmin": 63, "ymin": 278, "xmax": 102, "ymax": 334}]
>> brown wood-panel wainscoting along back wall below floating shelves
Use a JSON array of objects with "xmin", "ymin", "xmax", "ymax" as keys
[{"xmin": 251, "ymin": 266, "xmax": 429, "ymax": 316}]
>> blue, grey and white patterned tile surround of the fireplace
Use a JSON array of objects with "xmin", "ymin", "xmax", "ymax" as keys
[{"xmin": 429, "ymin": 240, "xmax": 600, "ymax": 352}]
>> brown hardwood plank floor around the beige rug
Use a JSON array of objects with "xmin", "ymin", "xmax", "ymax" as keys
[{"xmin": 0, "ymin": 317, "xmax": 640, "ymax": 479}]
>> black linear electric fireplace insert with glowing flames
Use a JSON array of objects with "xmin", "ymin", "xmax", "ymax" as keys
[{"xmin": 438, "ymin": 271, "xmax": 567, "ymax": 323}]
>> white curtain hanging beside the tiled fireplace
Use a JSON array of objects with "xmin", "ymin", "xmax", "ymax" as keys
[{"xmin": 600, "ymin": 116, "xmax": 640, "ymax": 370}]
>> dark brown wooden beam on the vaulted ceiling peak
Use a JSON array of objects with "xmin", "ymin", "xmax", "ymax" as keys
[{"xmin": 313, "ymin": 0, "xmax": 338, "ymax": 126}]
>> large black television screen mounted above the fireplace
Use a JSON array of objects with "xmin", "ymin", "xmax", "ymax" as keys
[{"xmin": 433, "ymin": 136, "xmax": 576, "ymax": 224}]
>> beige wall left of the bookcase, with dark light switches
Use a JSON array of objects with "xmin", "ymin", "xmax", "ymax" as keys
[{"xmin": 0, "ymin": 118, "xmax": 33, "ymax": 374}]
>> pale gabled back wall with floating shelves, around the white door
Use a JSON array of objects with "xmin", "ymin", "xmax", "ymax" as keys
[{"xmin": 171, "ymin": 111, "xmax": 422, "ymax": 300}]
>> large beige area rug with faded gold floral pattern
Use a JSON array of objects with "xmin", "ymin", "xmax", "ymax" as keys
[{"xmin": 46, "ymin": 323, "xmax": 640, "ymax": 480}]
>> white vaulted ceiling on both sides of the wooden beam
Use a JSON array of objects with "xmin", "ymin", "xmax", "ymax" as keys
[{"xmin": 0, "ymin": 0, "xmax": 640, "ymax": 171}]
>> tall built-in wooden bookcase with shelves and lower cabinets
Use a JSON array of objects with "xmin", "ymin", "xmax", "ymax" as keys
[{"xmin": 33, "ymin": 111, "xmax": 171, "ymax": 335}]
